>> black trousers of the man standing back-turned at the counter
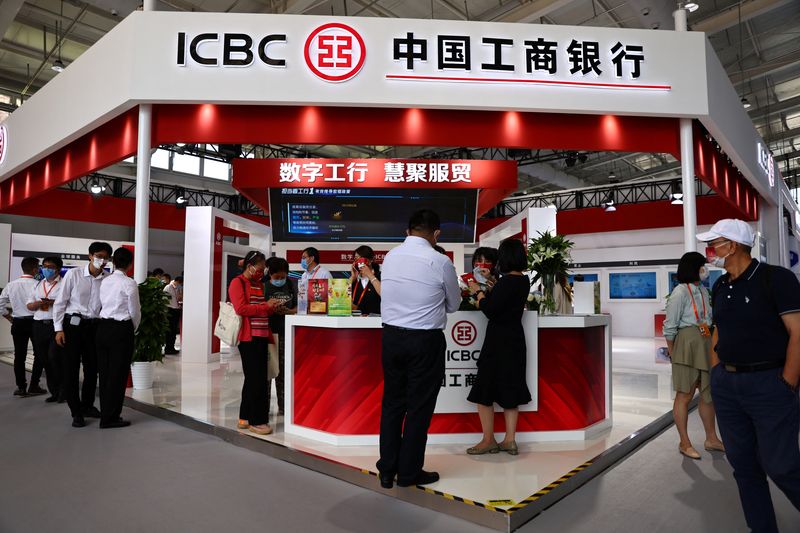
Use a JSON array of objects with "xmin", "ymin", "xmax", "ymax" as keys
[{"xmin": 377, "ymin": 327, "xmax": 447, "ymax": 482}]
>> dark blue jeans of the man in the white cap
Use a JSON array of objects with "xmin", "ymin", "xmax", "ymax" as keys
[{"xmin": 711, "ymin": 365, "xmax": 800, "ymax": 533}]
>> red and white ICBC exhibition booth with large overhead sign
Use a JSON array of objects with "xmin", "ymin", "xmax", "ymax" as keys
[{"xmin": 0, "ymin": 8, "xmax": 797, "ymax": 529}]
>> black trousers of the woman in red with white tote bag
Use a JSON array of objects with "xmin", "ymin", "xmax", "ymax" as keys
[{"xmin": 239, "ymin": 337, "xmax": 270, "ymax": 426}]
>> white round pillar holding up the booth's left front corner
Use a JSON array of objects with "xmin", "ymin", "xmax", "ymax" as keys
[{"xmin": 133, "ymin": 104, "xmax": 153, "ymax": 283}]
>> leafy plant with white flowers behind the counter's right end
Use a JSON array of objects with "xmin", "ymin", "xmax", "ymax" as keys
[{"xmin": 528, "ymin": 231, "xmax": 575, "ymax": 313}]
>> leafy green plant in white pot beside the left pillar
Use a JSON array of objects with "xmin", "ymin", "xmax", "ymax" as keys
[{"xmin": 131, "ymin": 278, "xmax": 169, "ymax": 389}]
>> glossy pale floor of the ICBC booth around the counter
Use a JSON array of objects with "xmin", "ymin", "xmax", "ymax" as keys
[{"xmin": 115, "ymin": 338, "xmax": 673, "ymax": 503}]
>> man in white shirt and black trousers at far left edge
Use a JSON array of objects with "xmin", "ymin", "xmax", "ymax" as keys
[{"xmin": 0, "ymin": 257, "xmax": 41, "ymax": 397}]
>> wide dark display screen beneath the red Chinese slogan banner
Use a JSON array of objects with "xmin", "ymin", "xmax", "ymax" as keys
[{"xmin": 270, "ymin": 188, "xmax": 478, "ymax": 243}]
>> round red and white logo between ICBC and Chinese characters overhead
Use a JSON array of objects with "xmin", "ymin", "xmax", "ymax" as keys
[{"xmin": 305, "ymin": 22, "xmax": 367, "ymax": 82}]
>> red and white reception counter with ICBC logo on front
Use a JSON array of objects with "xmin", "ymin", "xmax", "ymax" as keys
[{"xmin": 279, "ymin": 311, "xmax": 611, "ymax": 445}]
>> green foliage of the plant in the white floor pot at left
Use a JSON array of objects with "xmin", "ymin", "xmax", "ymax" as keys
[{"xmin": 133, "ymin": 278, "xmax": 169, "ymax": 363}]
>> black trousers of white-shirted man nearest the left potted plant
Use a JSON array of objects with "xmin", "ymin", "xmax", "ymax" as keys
[{"xmin": 97, "ymin": 319, "xmax": 133, "ymax": 424}]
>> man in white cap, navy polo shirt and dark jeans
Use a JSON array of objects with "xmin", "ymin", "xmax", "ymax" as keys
[{"xmin": 697, "ymin": 219, "xmax": 800, "ymax": 532}]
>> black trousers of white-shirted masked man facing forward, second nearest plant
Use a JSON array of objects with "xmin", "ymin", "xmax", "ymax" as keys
[{"xmin": 63, "ymin": 315, "xmax": 97, "ymax": 417}]
